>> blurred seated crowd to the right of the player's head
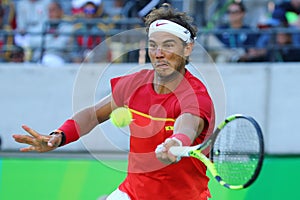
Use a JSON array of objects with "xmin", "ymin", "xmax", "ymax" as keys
[{"xmin": 201, "ymin": 0, "xmax": 300, "ymax": 62}]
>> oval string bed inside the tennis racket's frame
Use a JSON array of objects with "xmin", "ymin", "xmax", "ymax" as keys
[{"xmin": 211, "ymin": 118, "xmax": 260, "ymax": 185}]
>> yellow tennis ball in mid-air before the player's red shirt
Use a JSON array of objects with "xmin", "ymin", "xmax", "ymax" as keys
[{"xmin": 110, "ymin": 107, "xmax": 132, "ymax": 127}]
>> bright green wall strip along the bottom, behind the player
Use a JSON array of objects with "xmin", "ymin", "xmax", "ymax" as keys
[{"xmin": 0, "ymin": 157, "xmax": 300, "ymax": 200}]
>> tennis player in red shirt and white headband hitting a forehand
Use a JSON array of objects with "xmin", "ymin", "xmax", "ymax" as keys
[{"xmin": 13, "ymin": 4, "xmax": 214, "ymax": 200}]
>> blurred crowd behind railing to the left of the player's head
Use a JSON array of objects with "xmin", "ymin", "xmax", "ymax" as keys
[{"xmin": 0, "ymin": 0, "xmax": 168, "ymax": 66}]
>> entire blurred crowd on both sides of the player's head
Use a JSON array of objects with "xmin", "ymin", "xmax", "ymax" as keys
[{"xmin": 0, "ymin": 0, "xmax": 300, "ymax": 66}]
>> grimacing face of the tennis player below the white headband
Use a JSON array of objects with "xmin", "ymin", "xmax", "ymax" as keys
[{"xmin": 148, "ymin": 32, "xmax": 191, "ymax": 77}]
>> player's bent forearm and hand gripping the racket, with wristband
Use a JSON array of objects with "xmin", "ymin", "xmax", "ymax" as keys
[{"xmin": 155, "ymin": 113, "xmax": 205, "ymax": 164}]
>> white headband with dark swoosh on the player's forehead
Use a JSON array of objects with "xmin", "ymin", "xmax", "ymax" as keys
[{"xmin": 148, "ymin": 19, "xmax": 192, "ymax": 43}]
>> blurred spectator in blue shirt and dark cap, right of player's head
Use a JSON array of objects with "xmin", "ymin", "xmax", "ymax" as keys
[{"xmin": 216, "ymin": 2, "xmax": 261, "ymax": 62}]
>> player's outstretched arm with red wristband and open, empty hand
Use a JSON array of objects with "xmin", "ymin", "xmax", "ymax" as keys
[{"xmin": 13, "ymin": 95, "xmax": 116, "ymax": 152}]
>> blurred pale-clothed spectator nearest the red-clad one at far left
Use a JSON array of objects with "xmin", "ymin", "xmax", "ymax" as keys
[{"xmin": 15, "ymin": 0, "xmax": 50, "ymax": 61}]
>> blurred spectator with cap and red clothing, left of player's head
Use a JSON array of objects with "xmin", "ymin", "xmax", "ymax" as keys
[{"xmin": 72, "ymin": 1, "xmax": 113, "ymax": 63}]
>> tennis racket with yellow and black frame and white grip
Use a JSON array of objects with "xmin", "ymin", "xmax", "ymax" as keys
[{"xmin": 169, "ymin": 115, "xmax": 264, "ymax": 190}]
